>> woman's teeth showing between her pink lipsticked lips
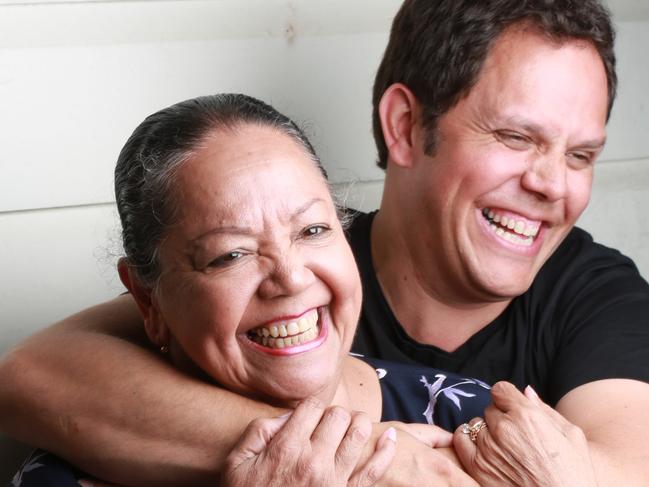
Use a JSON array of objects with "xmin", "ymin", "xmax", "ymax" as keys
[{"xmin": 248, "ymin": 309, "xmax": 318, "ymax": 348}]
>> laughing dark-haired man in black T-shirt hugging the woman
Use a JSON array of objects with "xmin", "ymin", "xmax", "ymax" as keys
[{"xmin": 0, "ymin": 0, "xmax": 649, "ymax": 485}]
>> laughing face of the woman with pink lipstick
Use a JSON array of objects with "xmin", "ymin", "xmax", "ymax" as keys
[{"xmin": 147, "ymin": 125, "xmax": 361, "ymax": 405}]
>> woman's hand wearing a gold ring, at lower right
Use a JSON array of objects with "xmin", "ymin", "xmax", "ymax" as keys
[{"xmin": 454, "ymin": 382, "xmax": 597, "ymax": 486}]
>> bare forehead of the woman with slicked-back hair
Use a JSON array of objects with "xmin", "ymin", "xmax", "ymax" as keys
[{"xmin": 165, "ymin": 125, "xmax": 328, "ymax": 235}]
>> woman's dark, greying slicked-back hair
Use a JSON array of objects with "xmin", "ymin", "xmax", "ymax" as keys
[{"xmin": 115, "ymin": 93, "xmax": 327, "ymax": 287}]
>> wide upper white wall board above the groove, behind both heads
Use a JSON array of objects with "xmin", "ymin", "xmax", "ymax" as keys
[{"xmin": 0, "ymin": 0, "xmax": 649, "ymax": 212}]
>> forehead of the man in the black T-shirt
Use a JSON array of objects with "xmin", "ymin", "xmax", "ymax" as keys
[{"xmin": 467, "ymin": 29, "xmax": 607, "ymax": 135}]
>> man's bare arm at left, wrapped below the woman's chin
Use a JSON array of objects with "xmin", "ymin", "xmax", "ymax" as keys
[{"xmin": 0, "ymin": 296, "xmax": 278, "ymax": 485}]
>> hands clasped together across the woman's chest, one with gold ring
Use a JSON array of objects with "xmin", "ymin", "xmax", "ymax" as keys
[{"xmin": 222, "ymin": 382, "xmax": 596, "ymax": 487}]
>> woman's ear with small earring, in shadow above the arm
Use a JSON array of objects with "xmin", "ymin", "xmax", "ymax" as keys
[{"xmin": 117, "ymin": 259, "xmax": 171, "ymax": 347}]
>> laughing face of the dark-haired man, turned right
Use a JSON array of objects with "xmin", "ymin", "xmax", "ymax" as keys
[{"xmin": 404, "ymin": 28, "xmax": 608, "ymax": 302}]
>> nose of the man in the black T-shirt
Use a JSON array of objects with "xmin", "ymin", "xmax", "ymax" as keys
[{"xmin": 521, "ymin": 153, "xmax": 568, "ymax": 202}]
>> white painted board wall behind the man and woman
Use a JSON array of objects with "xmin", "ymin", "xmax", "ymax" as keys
[{"xmin": 0, "ymin": 0, "xmax": 649, "ymax": 482}]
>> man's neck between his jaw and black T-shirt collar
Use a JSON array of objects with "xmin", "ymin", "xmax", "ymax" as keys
[{"xmin": 371, "ymin": 211, "xmax": 511, "ymax": 352}]
